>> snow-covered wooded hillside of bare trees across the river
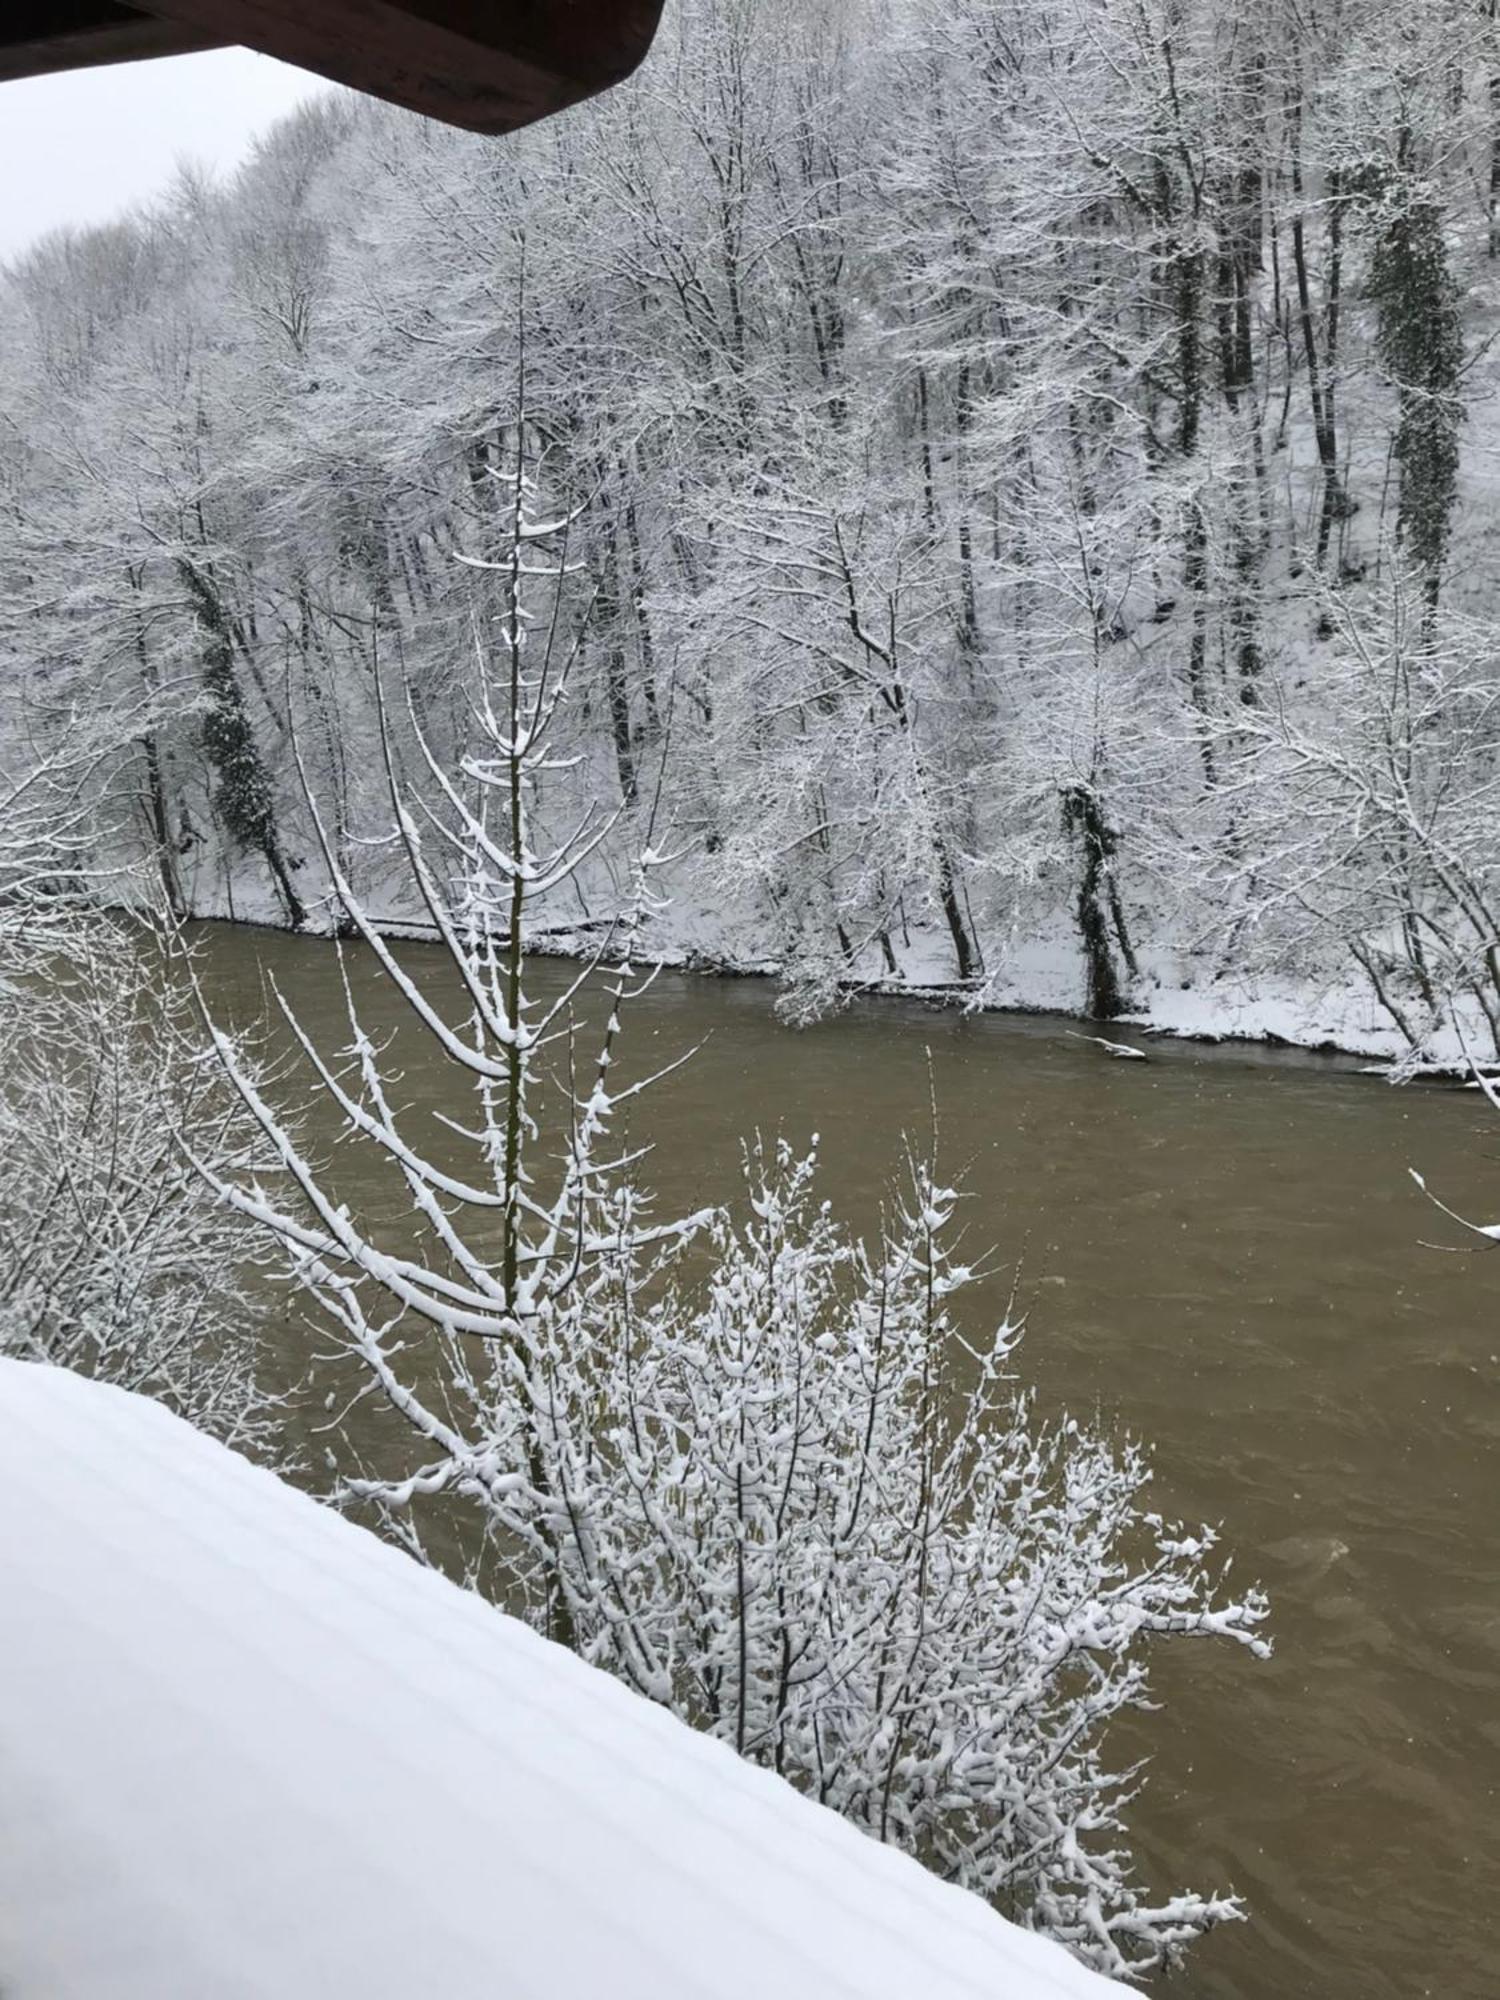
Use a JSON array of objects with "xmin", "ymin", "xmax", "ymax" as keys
[{"xmin": 0, "ymin": 0, "xmax": 1500, "ymax": 1060}]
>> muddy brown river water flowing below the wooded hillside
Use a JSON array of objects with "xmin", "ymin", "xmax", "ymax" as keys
[{"xmin": 204, "ymin": 928, "xmax": 1500, "ymax": 2000}]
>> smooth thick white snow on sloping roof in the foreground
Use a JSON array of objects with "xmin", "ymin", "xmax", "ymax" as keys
[{"xmin": 0, "ymin": 1360, "xmax": 1116, "ymax": 2000}]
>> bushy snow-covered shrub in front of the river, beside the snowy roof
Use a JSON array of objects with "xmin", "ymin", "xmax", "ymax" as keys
[{"xmin": 516, "ymin": 1144, "xmax": 1264, "ymax": 1978}]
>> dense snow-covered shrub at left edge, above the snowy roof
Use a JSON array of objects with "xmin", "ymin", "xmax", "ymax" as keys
[{"xmin": 0, "ymin": 920, "xmax": 270, "ymax": 1448}]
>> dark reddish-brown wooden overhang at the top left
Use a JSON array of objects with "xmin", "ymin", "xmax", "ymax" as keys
[{"xmin": 0, "ymin": 0, "xmax": 662, "ymax": 132}]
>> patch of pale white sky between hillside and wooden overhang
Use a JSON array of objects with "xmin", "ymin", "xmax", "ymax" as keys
[{"xmin": 0, "ymin": 48, "xmax": 328, "ymax": 258}]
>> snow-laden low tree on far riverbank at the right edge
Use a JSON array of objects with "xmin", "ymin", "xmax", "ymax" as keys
[{"xmin": 1216, "ymin": 566, "xmax": 1500, "ymax": 1060}]
